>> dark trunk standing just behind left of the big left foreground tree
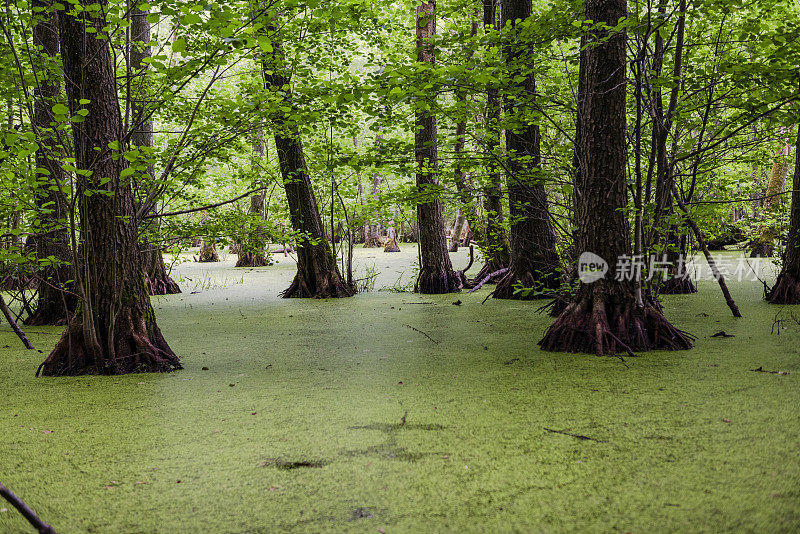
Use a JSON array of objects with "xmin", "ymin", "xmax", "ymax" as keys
[{"xmin": 25, "ymin": 0, "xmax": 78, "ymax": 325}]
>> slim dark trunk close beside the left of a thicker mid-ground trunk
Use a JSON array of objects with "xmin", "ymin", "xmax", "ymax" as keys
[{"xmin": 472, "ymin": 0, "xmax": 511, "ymax": 283}]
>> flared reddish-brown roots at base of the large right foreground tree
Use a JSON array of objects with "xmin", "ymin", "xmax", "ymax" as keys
[{"xmin": 539, "ymin": 283, "xmax": 694, "ymax": 356}]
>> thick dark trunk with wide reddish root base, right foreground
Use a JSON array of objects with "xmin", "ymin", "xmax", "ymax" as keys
[{"xmin": 539, "ymin": 0, "xmax": 692, "ymax": 355}]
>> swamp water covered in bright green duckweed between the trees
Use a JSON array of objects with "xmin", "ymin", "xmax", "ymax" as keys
[{"xmin": 0, "ymin": 249, "xmax": 800, "ymax": 533}]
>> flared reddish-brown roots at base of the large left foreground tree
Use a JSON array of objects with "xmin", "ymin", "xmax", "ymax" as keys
[{"xmin": 36, "ymin": 308, "xmax": 182, "ymax": 376}]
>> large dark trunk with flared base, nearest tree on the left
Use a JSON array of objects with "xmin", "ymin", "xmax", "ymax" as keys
[{"xmin": 40, "ymin": 0, "xmax": 181, "ymax": 376}]
